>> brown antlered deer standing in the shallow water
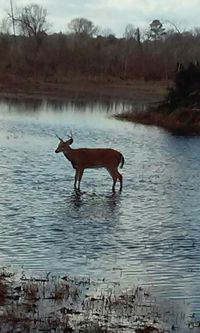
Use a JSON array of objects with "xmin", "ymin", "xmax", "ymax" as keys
[{"xmin": 55, "ymin": 134, "xmax": 124, "ymax": 192}]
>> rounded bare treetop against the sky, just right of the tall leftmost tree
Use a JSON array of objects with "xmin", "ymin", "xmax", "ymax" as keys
[{"xmin": 68, "ymin": 17, "xmax": 99, "ymax": 37}]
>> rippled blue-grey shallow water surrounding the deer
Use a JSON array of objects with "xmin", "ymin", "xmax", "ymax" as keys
[{"xmin": 0, "ymin": 101, "xmax": 200, "ymax": 320}]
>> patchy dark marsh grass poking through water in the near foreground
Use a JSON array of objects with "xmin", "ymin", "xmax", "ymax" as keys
[{"xmin": 0, "ymin": 270, "xmax": 191, "ymax": 333}]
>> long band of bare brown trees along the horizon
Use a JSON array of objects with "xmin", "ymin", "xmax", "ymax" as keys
[{"xmin": 0, "ymin": 5, "xmax": 200, "ymax": 81}]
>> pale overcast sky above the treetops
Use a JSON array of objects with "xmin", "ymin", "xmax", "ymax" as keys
[{"xmin": 0, "ymin": 0, "xmax": 200, "ymax": 36}]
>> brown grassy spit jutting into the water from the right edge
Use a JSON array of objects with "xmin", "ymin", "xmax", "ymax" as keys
[{"xmin": 115, "ymin": 108, "xmax": 200, "ymax": 136}]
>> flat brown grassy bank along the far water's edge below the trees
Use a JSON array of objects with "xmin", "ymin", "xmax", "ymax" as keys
[{"xmin": 0, "ymin": 74, "xmax": 168, "ymax": 103}]
